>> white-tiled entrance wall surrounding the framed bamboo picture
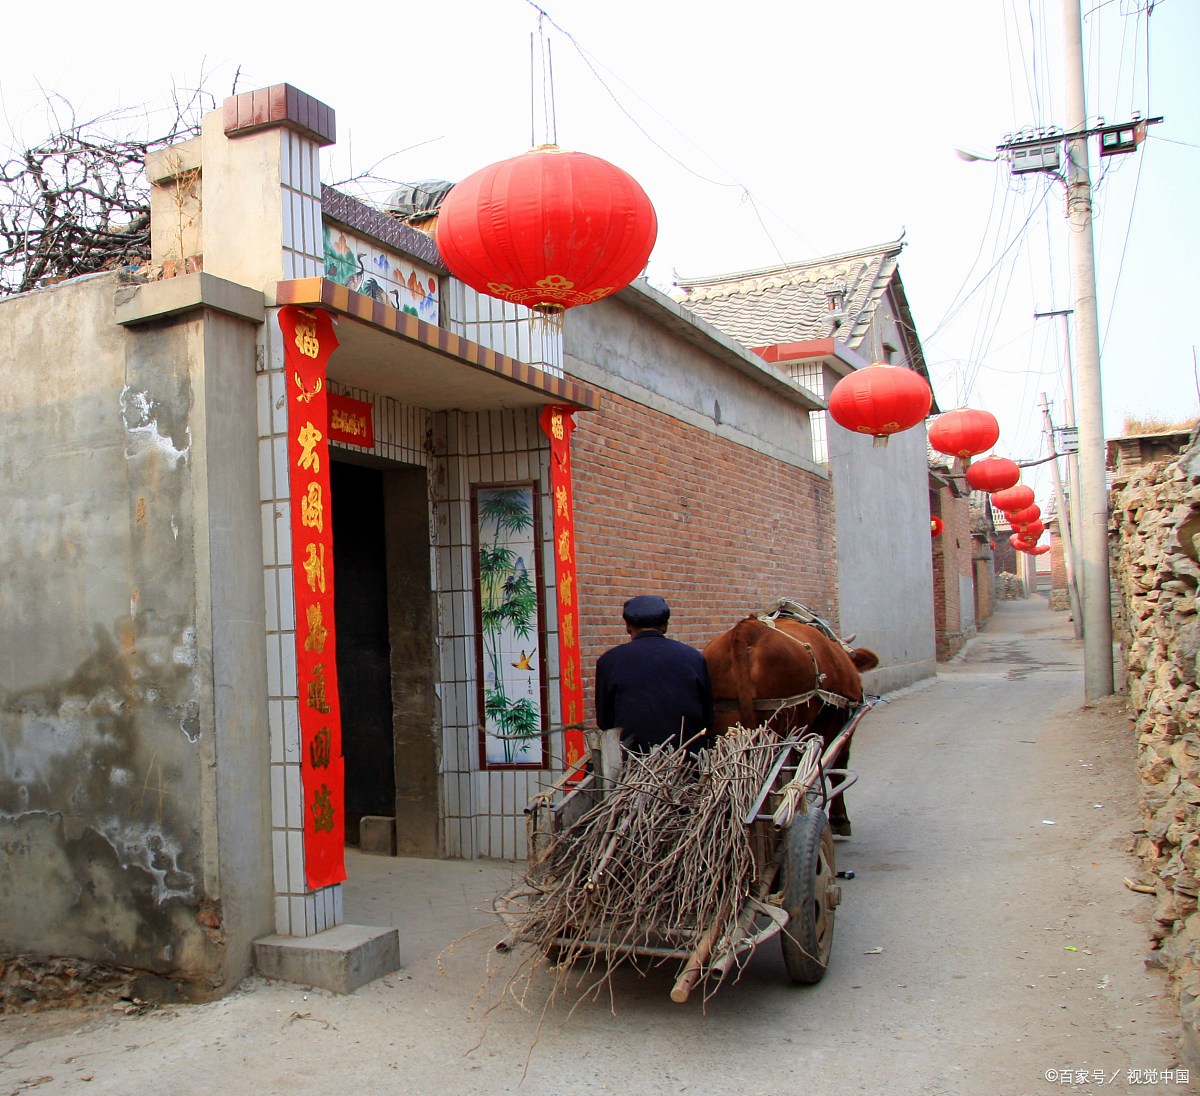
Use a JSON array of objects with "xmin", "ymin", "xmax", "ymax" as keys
[{"xmin": 434, "ymin": 409, "xmax": 562, "ymax": 858}]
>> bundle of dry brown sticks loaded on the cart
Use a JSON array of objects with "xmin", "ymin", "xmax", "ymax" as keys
[{"xmin": 505, "ymin": 726, "xmax": 781, "ymax": 996}]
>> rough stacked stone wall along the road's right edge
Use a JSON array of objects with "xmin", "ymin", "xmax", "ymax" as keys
[{"xmin": 1111, "ymin": 424, "xmax": 1200, "ymax": 1061}]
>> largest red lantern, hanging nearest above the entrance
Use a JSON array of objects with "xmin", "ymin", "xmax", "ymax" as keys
[{"xmin": 434, "ymin": 145, "xmax": 658, "ymax": 312}]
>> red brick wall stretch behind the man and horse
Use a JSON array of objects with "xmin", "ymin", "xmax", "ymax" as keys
[{"xmin": 571, "ymin": 393, "xmax": 838, "ymax": 712}]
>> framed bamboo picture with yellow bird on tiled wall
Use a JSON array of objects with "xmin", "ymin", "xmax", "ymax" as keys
[{"xmin": 470, "ymin": 483, "xmax": 550, "ymax": 768}]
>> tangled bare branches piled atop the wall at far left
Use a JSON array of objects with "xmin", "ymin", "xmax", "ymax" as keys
[{"xmin": 0, "ymin": 91, "xmax": 211, "ymax": 297}]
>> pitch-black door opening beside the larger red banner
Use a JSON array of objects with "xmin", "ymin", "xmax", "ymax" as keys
[{"xmin": 330, "ymin": 461, "xmax": 396, "ymax": 845}]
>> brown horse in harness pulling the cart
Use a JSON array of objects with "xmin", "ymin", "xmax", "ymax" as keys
[{"xmin": 703, "ymin": 616, "xmax": 880, "ymax": 836}]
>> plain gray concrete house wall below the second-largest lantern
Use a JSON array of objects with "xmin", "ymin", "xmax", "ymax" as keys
[{"xmin": 828, "ymin": 420, "xmax": 937, "ymax": 694}]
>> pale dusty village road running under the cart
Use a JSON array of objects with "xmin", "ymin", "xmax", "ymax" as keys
[{"xmin": 0, "ymin": 599, "xmax": 1200, "ymax": 1096}]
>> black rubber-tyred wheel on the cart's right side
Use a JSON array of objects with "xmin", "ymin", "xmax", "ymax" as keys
[{"xmin": 779, "ymin": 810, "xmax": 841, "ymax": 986}]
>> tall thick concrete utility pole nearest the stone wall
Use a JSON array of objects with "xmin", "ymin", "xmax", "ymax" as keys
[{"xmin": 1063, "ymin": 0, "xmax": 1112, "ymax": 700}]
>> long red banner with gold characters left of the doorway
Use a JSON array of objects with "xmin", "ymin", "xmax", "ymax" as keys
[{"xmin": 280, "ymin": 305, "xmax": 346, "ymax": 891}]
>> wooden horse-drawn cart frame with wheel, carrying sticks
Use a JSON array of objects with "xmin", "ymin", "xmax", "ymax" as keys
[{"xmin": 496, "ymin": 697, "xmax": 877, "ymax": 1001}]
